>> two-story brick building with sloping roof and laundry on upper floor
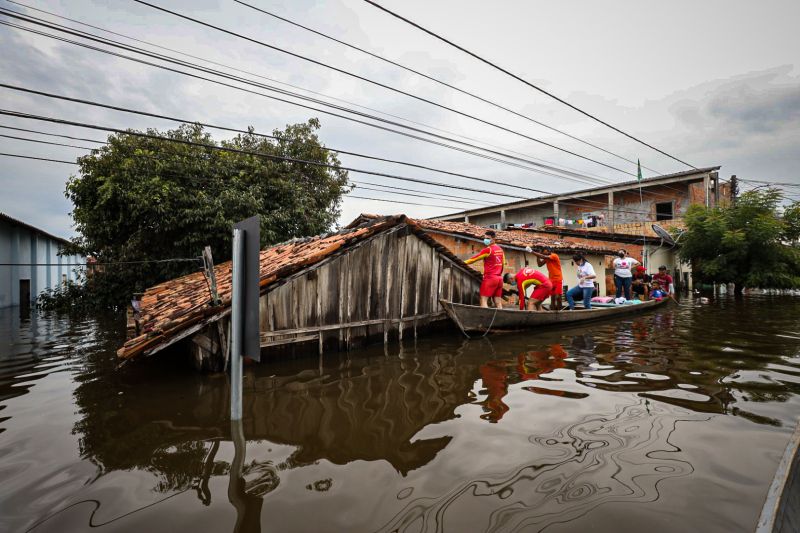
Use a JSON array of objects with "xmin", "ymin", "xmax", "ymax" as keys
[{"xmin": 433, "ymin": 166, "xmax": 731, "ymax": 289}]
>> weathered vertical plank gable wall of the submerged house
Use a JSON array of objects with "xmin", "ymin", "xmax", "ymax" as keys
[{"xmin": 260, "ymin": 226, "xmax": 479, "ymax": 353}]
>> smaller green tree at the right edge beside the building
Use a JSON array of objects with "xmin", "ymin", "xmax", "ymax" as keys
[{"xmin": 679, "ymin": 188, "xmax": 800, "ymax": 294}]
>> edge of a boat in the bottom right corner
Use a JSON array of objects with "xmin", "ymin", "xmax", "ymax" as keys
[{"xmin": 756, "ymin": 422, "xmax": 800, "ymax": 533}]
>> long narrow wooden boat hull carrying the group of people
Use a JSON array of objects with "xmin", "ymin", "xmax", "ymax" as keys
[{"xmin": 439, "ymin": 299, "xmax": 669, "ymax": 333}]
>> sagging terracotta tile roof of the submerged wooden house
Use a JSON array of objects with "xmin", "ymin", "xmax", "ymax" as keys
[{"xmin": 117, "ymin": 215, "xmax": 480, "ymax": 359}]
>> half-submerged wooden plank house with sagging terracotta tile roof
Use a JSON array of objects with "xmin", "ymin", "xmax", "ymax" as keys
[{"xmin": 117, "ymin": 215, "xmax": 481, "ymax": 370}]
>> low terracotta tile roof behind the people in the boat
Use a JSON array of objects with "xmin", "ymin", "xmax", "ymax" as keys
[{"xmin": 410, "ymin": 215, "xmax": 615, "ymax": 254}]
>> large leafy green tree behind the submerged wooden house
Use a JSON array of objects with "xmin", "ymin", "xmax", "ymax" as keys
[{"xmin": 65, "ymin": 119, "xmax": 349, "ymax": 307}]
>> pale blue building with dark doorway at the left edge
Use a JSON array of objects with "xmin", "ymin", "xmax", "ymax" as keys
[{"xmin": 0, "ymin": 213, "xmax": 84, "ymax": 307}]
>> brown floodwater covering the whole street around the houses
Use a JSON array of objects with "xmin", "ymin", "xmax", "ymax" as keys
[{"xmin": 0, "ymin": 296, "xmax": 800, "ymax": 533}]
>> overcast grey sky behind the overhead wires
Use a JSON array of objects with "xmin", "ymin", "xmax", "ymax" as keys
[{"xmin": 0, "ymin": 0, "xmax": 800, "ymax": 237}]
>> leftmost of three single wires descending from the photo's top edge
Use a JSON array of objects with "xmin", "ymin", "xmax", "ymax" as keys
[{"xmin": 132, "ymin": 0, "xmax": 636, "ymax": 176}]
